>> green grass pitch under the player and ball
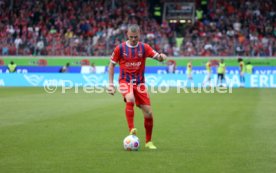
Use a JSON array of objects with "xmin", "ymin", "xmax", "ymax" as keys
[{"xmin": 0, "ymin": 88, "xmax": 276, "ymax": 173}]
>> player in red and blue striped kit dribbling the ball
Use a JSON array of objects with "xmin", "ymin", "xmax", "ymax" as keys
[{"xmin": 108, "ymin": 24, "xmax": 166, "ymax": 149}]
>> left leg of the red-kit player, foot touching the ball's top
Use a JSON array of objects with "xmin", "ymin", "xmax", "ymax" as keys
[{"xmin": 120, "ymin": 83, "xmax": 136, "ymax": 134}]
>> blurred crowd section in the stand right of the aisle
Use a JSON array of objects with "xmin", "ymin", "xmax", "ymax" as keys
[{"xmin": 181, "ymin": 0, "xmax": 276, "ymax": 56}]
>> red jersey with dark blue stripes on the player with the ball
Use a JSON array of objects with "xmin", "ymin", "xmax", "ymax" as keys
[{"xmin": 111, "ymin": 42, "xmax": 158, "ymax": 84}]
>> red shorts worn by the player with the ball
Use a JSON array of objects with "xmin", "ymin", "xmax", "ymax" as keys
[{"xmin": 119, "ymin": 82, "xmax": 150, "ymax": 106}]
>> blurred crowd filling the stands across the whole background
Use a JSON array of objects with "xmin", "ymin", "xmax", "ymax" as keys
[{"xmin": 0, "ymin": 0, "xmax": 276, "ymax": 56}]
